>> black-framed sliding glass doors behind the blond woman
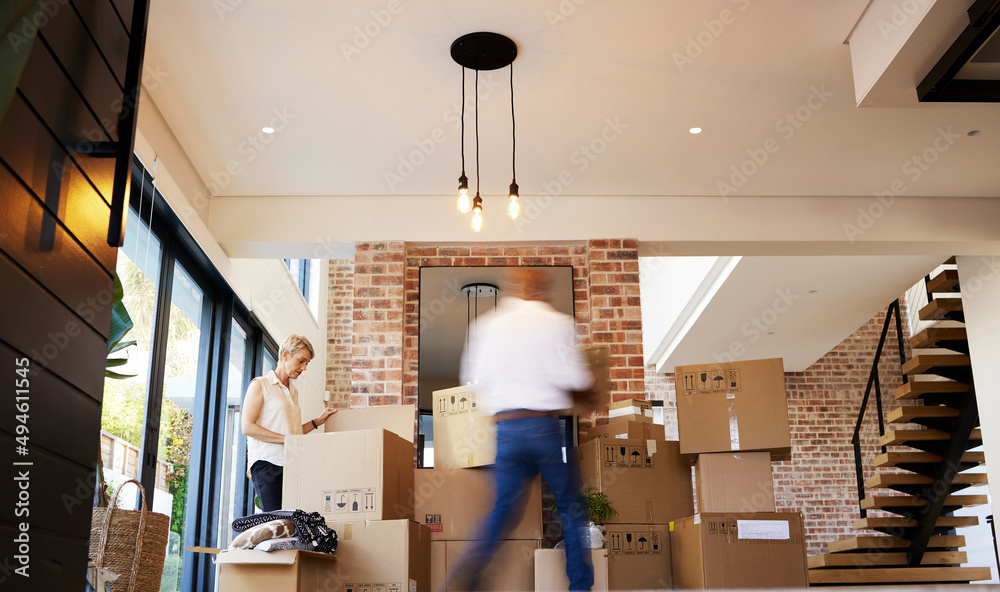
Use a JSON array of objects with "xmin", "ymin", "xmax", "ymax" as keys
[{"xmin": 100, "ymin": 162, "xmax": 276, "ymax": 592}]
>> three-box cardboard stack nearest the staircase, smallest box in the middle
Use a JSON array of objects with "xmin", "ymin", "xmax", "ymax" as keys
[{"xmin": 670, "ymin": 358, "xmax": 808, "ymax": 588}]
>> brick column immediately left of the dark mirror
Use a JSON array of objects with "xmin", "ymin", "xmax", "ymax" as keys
[{"xmin": 351, "ymin": 241, "xmax": 405, "ymax": 407}]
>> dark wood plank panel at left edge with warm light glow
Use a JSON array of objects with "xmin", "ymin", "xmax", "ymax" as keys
[{"xmin": 0, "ymin": 0, "xmax": 144, "ymax": 590}]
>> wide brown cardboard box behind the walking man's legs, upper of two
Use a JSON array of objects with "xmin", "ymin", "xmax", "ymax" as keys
[{"xmin": 412, "ymin": 468, "xmax": 542, "ymax": 541}]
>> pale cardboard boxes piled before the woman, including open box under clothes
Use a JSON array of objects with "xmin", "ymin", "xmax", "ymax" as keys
[{"xmin": 217, "ymin": 405, "xmax": 431, "ymax": 592}]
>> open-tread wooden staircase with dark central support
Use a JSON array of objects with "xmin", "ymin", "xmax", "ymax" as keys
[{"xmin": 809, "ymin": 259, "xmax": 991, "ymax": 586}]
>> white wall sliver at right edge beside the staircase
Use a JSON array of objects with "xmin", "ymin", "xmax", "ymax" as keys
[{"xmin": 956, "ymin": 255, "xmax": 1000, "ymax": 528}]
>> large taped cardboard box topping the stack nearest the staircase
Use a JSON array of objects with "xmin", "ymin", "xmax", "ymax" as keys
[{"xmin": 674, "ymin": 358, "xmax": 791, "ymax": 460}]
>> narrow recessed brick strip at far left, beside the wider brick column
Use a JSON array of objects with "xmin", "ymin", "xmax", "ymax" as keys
[{"xmin": 326, "ymin": 260, "xmax": 354, "ymax": 407}]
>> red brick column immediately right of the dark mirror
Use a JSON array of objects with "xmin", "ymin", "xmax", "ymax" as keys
[{"xmin": 588, "ymin": 239, "xmax": 646, "ymax": 401}]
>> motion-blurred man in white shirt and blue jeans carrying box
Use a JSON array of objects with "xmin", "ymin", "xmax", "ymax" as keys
[{"xmin": 448, "ymin": 267, "xmax": 594, "ymax": 590}]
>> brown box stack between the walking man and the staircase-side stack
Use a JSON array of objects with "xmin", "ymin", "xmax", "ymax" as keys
[{"xmin": 577, "ymin": 400, "xmax": 693, "ymax": 590}]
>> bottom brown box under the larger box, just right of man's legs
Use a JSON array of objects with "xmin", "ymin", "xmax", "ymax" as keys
[{"xmin": 604, "ymin": 524, "xmax": 673, "ymax": 590}]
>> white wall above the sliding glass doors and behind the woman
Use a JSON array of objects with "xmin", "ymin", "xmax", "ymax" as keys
[{"xmin": 135, "ymin": 90, "xmax": 328, "ymax": 419}]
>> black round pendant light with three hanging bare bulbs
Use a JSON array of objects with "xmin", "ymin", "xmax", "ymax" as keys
[{"xmin": 451, "ymin": 32, "xmax": 521, "ymax": 232}]
